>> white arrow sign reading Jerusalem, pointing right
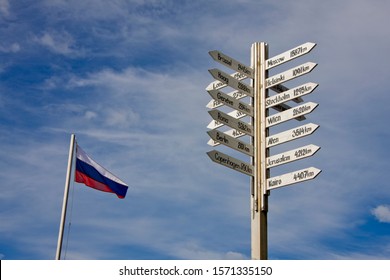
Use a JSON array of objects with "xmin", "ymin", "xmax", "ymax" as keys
[{"xmin": 266, "ymin": 145, "xmax": 320, "ymax": 168}]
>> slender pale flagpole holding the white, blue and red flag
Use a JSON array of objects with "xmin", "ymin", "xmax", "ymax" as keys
[{"xmin": 56, "ymin": 134, "xmax": 76, "ymax": 260}]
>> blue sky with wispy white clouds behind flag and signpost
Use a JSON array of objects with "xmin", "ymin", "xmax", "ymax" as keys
[{"xmin": 0, "ymin": 0, "xmax": 390, "ymax": 260}]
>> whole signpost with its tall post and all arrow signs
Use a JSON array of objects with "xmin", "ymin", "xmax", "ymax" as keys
[{"xmin": 206, "ymin": 42, "xmax": 321, "ymax": 259}]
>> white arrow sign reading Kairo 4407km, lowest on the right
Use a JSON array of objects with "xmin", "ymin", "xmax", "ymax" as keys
[{"xmin": 267, "ymin": 167, "xmax": 321, "ymax": 190}]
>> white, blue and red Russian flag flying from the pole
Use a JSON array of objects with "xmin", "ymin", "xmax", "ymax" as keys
[{"xmin": 75, "ymin": 145, "xmax": 128, "ymax": 198}]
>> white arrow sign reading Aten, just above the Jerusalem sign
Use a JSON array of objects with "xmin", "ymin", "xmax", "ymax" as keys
[{"xmin": 265, "ymin": 123, "xmax": 320, "ymax": 148}]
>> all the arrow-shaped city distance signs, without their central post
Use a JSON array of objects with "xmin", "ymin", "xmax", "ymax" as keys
[{"xmin": 206, "ymin": 43, "xmax": 321, "ymax": 190}]
